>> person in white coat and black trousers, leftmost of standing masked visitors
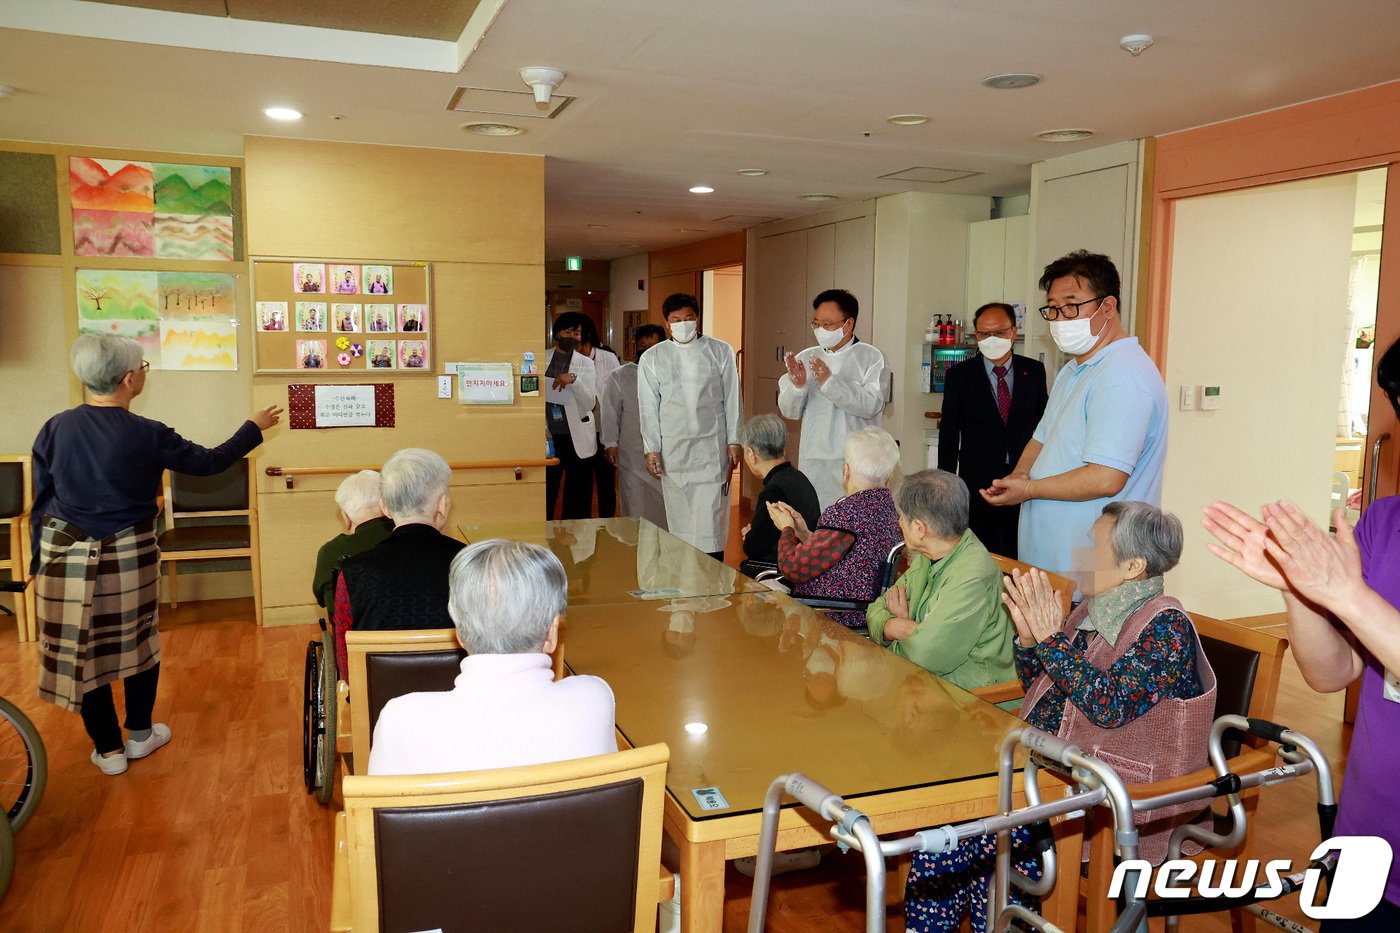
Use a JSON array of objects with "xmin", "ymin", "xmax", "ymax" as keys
[{"xmin": 545, "ymin": 311, "xmax": 598, "ymax": 518}]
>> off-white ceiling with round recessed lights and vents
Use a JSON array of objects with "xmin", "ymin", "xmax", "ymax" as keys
[{"xmin": 0, "ymin": 0, "xmax": 1400, "ymax": 259}]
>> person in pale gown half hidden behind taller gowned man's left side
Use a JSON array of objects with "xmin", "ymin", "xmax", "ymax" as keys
[{"xmin": 598, "ymin": 324, "xmax": 666, "ymax": 528}]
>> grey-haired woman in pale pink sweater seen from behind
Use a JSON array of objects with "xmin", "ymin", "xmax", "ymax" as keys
[{"xmin": 370, "ymin": 538, "xmax": 617, "ymax": 775}]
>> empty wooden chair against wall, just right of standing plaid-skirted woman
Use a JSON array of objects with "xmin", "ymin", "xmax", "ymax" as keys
[{"xmin": 158, "ymin": 458, "xmax": 262, "ymax": 625}]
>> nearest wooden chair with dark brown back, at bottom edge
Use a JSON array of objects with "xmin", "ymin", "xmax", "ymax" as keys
[{"xmin": 330, "ymin": 744, "xmax": 671, "ymax": 933}]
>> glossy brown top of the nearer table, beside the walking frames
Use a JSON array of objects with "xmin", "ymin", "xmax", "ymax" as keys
[{"xmin": 563, "ymin": 591, "xmax": 1021, "ymax": 821}]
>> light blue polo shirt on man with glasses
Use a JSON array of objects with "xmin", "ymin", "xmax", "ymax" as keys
[{"xmin": 1019, "ymin": 338, "xmax": 1166, "ymax": 579}]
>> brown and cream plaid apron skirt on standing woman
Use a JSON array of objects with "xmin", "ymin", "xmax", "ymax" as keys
[{"xmin": 35, "ymin": 516, "xmax": 161, "ymax": 713}]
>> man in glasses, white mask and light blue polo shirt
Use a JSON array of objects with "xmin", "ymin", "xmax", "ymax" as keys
[{"xmin": 981, "ymin": 249, "xmax": 1166, "ymax": 591}]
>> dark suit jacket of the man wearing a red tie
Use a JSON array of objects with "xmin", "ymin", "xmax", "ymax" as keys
[{"xmin": 938, "ymin": 354, "xmax": 1050, "ymax": 497}]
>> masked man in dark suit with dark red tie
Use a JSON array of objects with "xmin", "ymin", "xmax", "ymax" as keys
[{"xmin": 938, "ymin": 301, "xmax": 1049, "ymax": 558}]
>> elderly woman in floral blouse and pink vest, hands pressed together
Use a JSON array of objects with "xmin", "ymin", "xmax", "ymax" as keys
[{"xmin": 904, "ymin": 502, "xmax": 1215, "ymax": 933}]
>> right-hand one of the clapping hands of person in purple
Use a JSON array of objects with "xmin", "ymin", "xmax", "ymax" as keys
[{"xmin": 1261, "ymin": 500, "xmax": 1366, "ymax": 612}]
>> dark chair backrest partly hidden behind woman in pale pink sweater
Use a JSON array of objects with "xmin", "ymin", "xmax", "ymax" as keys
[{"xmin": 346, "ymin": 629, "xmax": 466, "ymax": 772}]
